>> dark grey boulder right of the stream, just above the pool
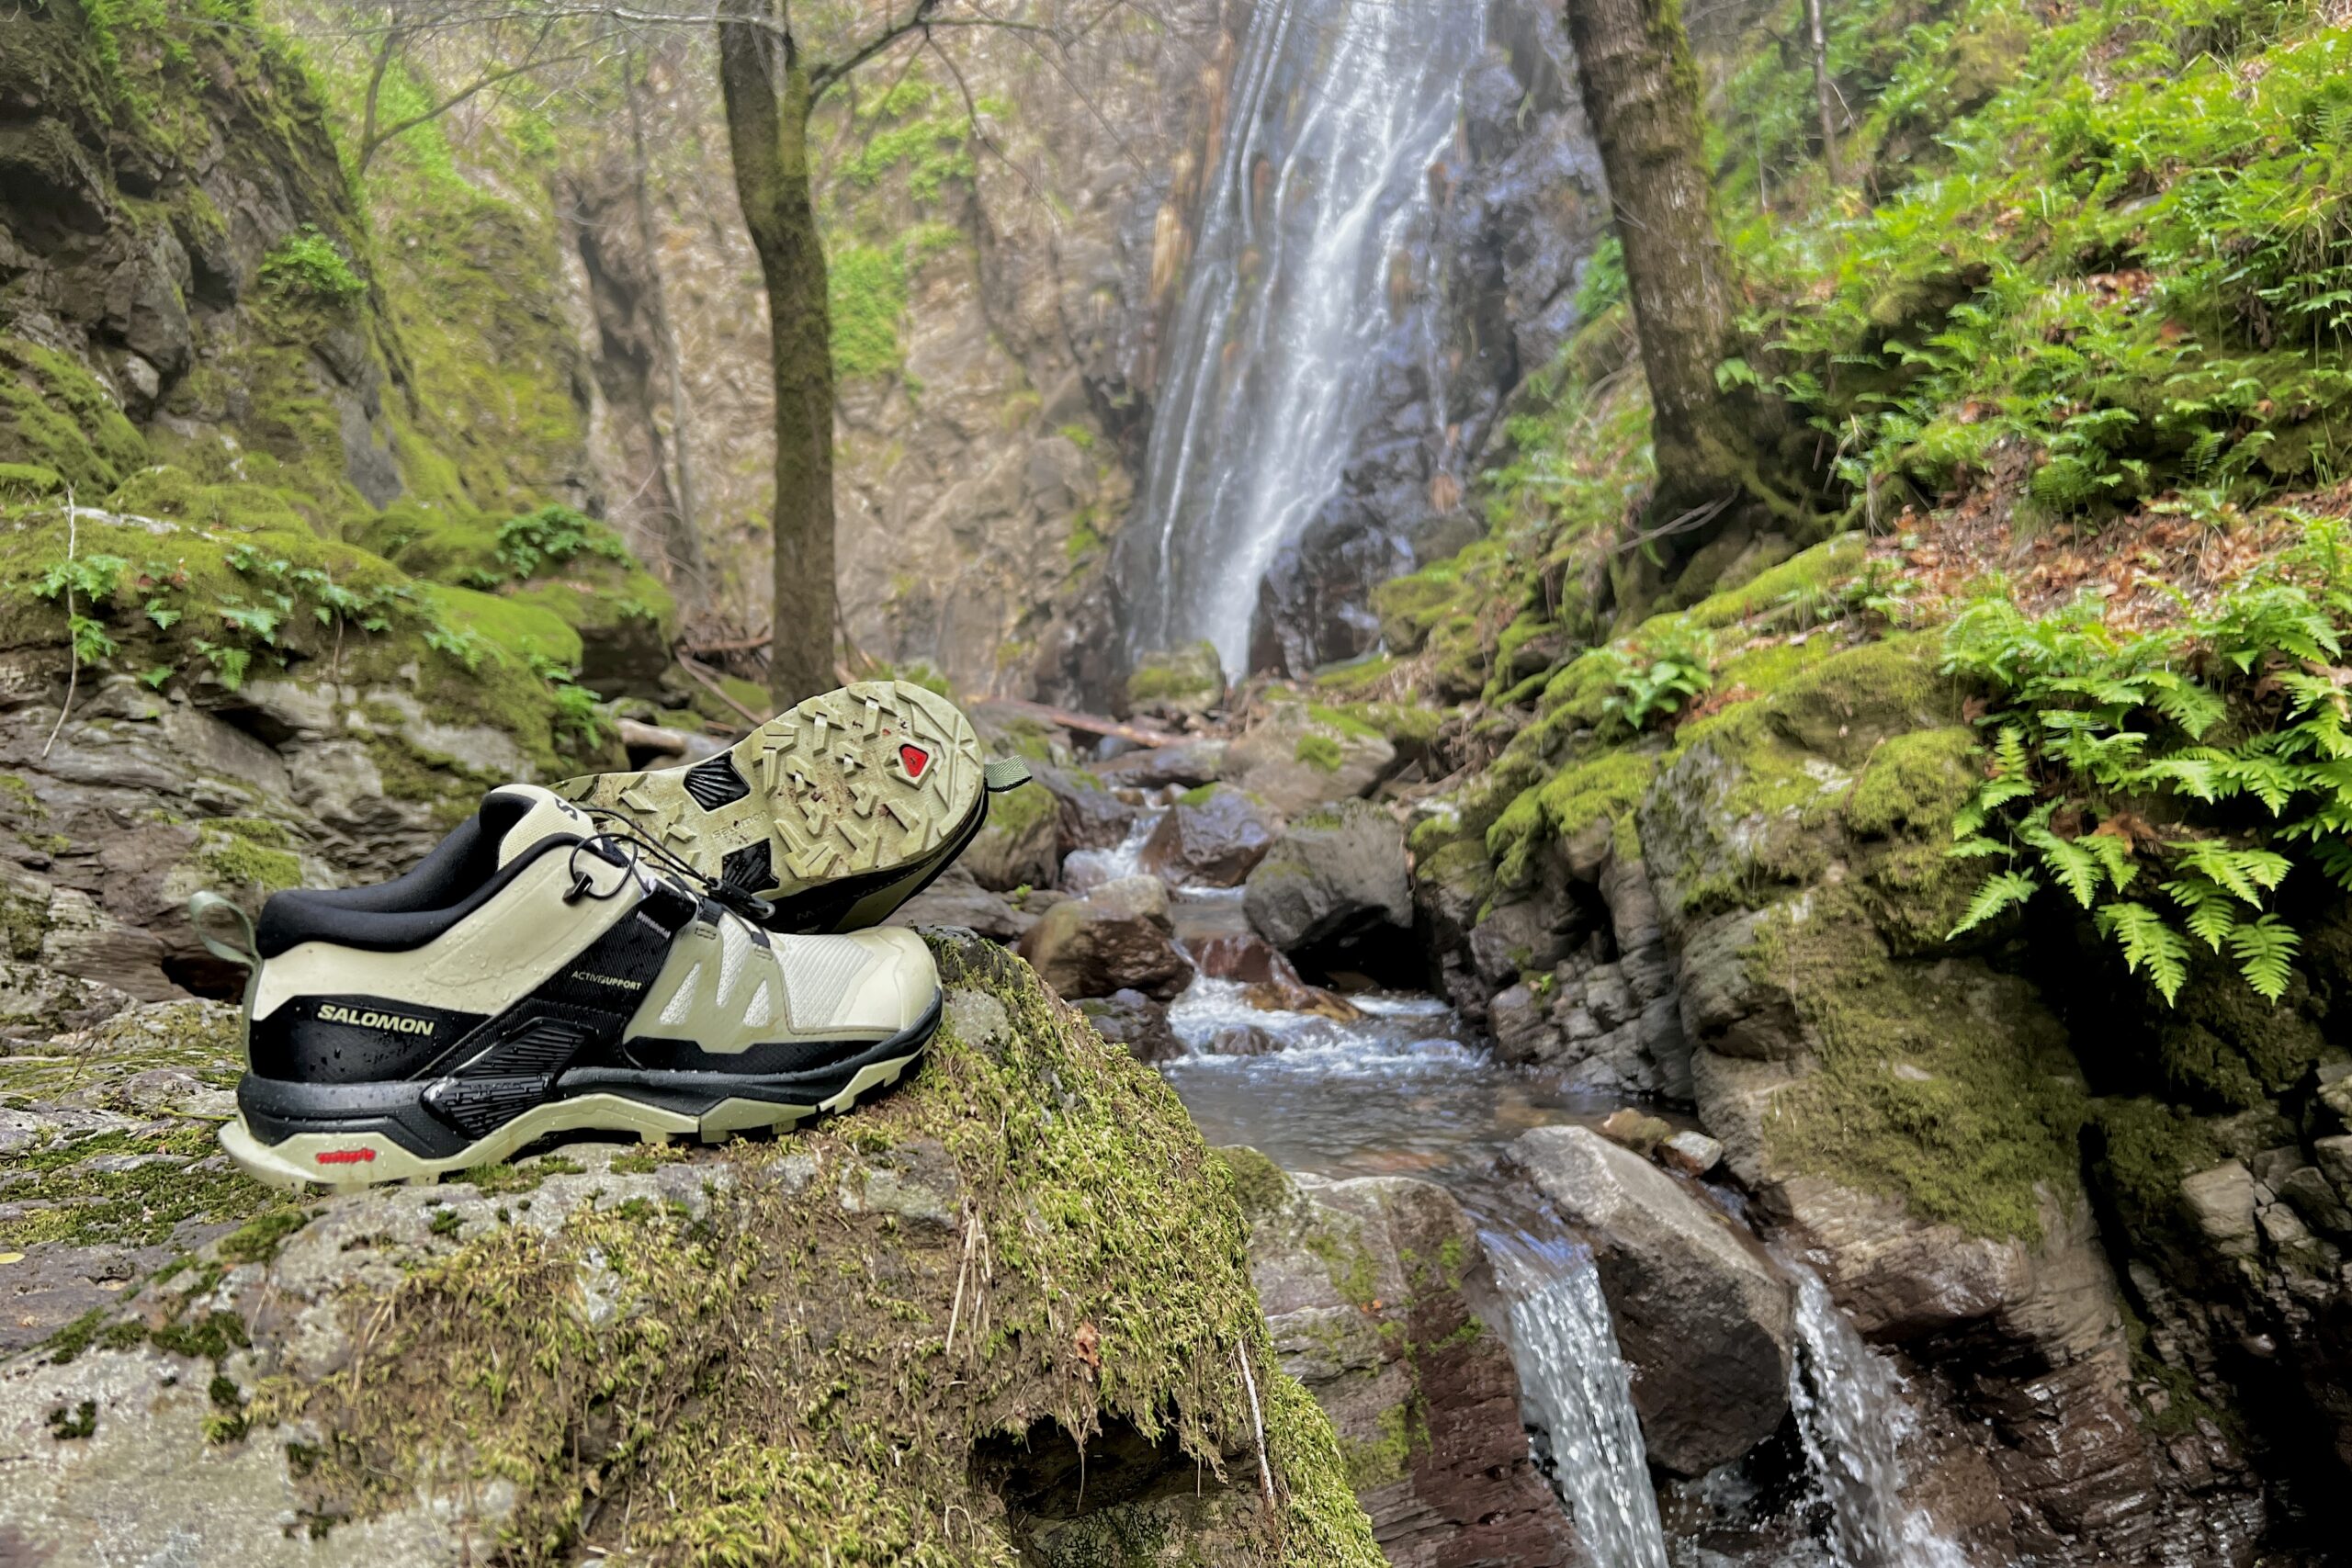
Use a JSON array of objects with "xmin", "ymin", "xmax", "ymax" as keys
[{"xmin": 1242, "ymin": 802, "xmax": 1414, "ymax": 952}]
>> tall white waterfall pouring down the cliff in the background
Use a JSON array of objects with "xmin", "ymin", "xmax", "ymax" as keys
[{"xmin": 1122, "ymin": 0, "xmax": 1484, "ymax": 672}]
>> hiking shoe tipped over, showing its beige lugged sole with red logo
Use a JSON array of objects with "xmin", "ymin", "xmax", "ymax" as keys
[{"xmin": 555, "ymin": 682, "xmax": 1028, "ymax": 931}]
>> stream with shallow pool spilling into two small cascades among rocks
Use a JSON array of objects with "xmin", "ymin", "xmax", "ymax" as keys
[{"xmin": 1110, "ymin": 851, "xmax": 1969, "ymax": 1568}]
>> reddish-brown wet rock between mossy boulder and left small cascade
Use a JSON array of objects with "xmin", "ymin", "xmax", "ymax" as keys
[{"xmin": 1226, "ymin": 1149, "xmax": 1583, "ymax": 1568}]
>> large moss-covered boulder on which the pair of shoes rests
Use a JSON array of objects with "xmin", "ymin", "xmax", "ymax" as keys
[{"xmin": 0, "ymin": 942, "xmax": 1381, "ymax": 1568}]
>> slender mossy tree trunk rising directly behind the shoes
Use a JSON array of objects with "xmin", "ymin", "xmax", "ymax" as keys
[{"xmin": 718, "ymin": 0, "xmax": 835, "ymax": 710}]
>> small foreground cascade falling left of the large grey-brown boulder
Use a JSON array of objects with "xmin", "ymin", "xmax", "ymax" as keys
[{"xmin": 1482, "ymin": 1232, "xmax": 1668, "ymax": 1568}]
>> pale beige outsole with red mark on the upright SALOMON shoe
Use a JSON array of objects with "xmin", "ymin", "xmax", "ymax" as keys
[{"xmin": 221, "ymin": 1042, "xmax": 927, "ymax": 1192}]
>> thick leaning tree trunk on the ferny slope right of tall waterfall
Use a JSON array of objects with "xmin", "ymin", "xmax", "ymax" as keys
[{"xmin": 1566, "ymin": 0, "xmax": 1799, "ymax": 581}]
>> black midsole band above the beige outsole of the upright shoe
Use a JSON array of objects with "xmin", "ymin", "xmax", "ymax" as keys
[{"xmin": 238, "ymin": 997, "xmax": 941, "ymax": 1159}]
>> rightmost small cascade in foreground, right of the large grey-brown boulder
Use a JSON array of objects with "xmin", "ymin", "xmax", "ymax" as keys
[{"xmin": 1776, "ymin": 1248, "xmax": 1969, "ymax": 1568}]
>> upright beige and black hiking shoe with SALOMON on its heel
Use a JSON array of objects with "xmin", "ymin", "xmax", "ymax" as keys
[{"xmin": 190, "ymin": 785, "xmax": 938, "ymax": 1187}]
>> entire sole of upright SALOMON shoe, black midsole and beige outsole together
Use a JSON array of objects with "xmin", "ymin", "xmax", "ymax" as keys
[{"xmin": 221, "ymin": 1004, "xmax": 938, "ymax": 1192}]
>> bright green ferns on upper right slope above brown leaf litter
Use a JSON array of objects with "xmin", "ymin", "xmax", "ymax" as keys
[{"xmin": 1726, "ymin": 0, "xmax": 2352, "ymax": 517}]
